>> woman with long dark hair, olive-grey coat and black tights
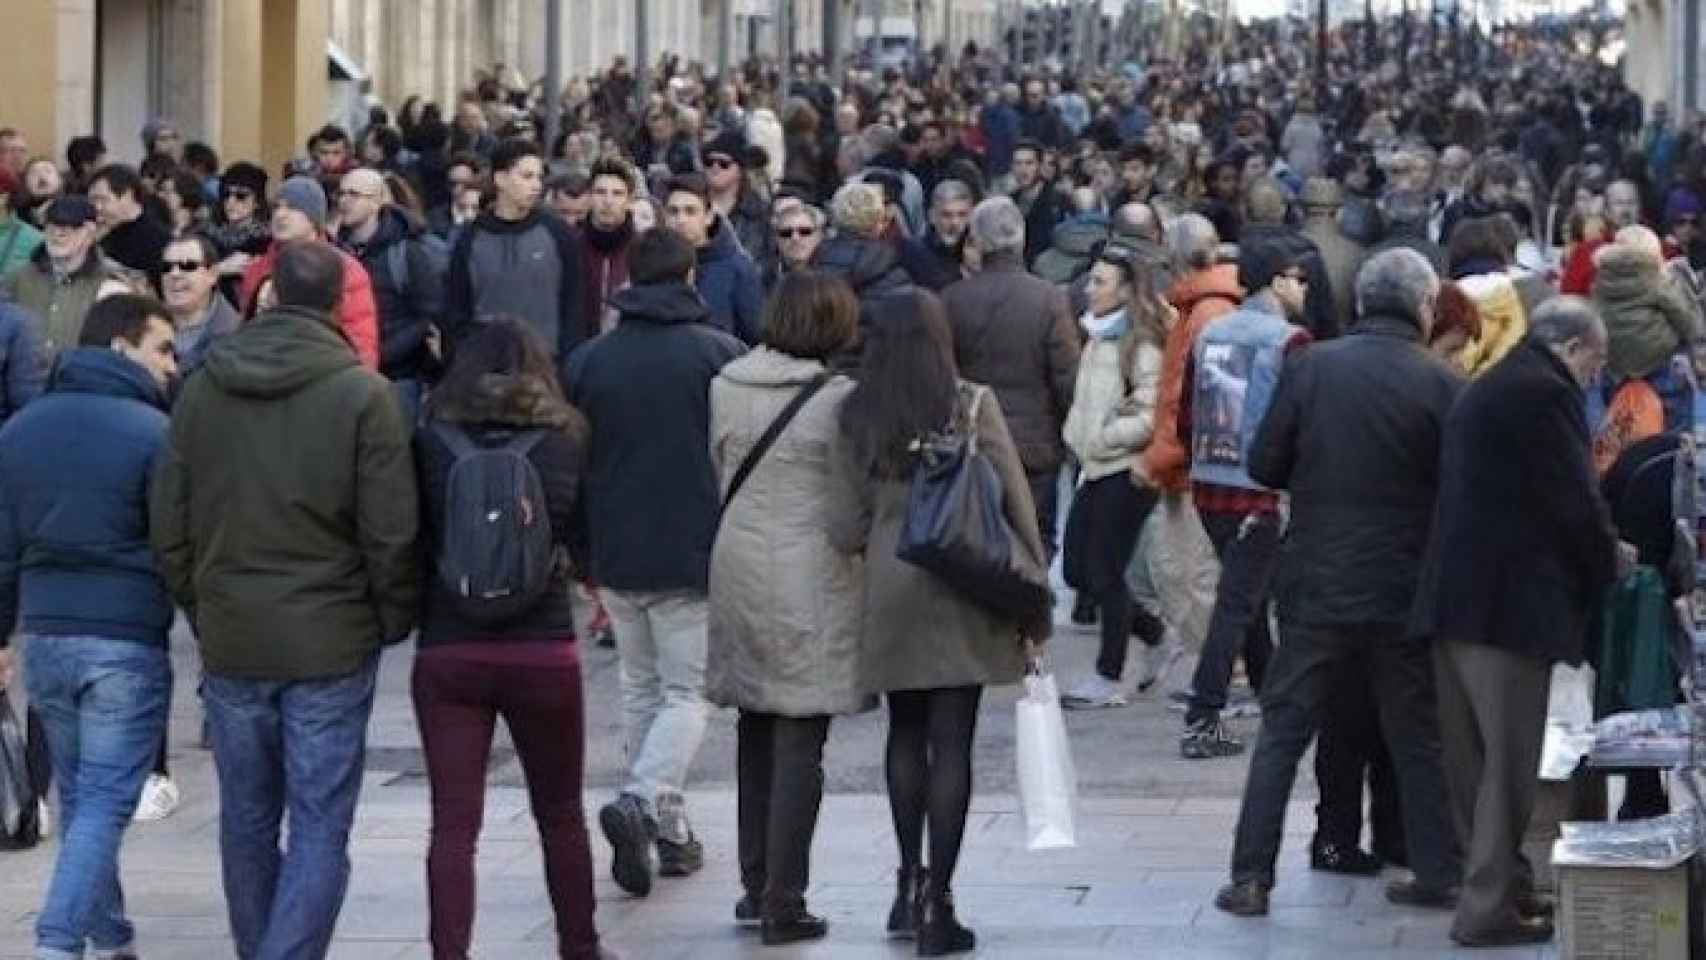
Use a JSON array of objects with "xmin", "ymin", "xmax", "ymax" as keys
[{"xmin": 829, "ymin": 292, "xmax": 1049, "ymax": 957}]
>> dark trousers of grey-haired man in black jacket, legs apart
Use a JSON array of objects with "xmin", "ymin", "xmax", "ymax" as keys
[{"xmin": 1232, "ymin": 624, "xmax": 1460, "ymax": 887}]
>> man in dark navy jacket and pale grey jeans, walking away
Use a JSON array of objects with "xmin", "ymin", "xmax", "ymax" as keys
[{"xmin": 568, "ymin": 228, "xmax": 746, "ymax": 897}]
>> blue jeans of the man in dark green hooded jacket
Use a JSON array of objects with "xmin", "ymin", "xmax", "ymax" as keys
[{"xmin": 201, "ymin": 653, "xmax": 379, "ymax": 960}]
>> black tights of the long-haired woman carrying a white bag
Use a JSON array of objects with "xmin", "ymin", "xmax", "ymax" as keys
[{"xmin": 885, "ymin": 687, "xmax": 983, "ymax": 897}]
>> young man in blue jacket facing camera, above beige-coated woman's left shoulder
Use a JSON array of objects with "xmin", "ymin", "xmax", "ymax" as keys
[{"xmin": 664, "ymin": 174, "xmax": 764, "ymax": 344}]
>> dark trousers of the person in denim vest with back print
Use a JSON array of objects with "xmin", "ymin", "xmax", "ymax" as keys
[{"xmin": 1186, "ymin": 513, "xmax": 1280, "ymax": 723}]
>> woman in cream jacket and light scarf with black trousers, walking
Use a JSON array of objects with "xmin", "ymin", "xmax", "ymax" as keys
[{"xmin": 1061, "ymin": 246, "xmax": 1177, "ymax": 708}]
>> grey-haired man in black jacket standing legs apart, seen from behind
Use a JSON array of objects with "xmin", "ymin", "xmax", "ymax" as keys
[{"xmin": 1215, "ymin": 251, "xmax": 1460, "ymax": 916}]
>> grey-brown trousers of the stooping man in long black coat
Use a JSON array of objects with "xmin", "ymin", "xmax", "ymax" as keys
[{"xmin": 1433, "ymin": 641, "xmax": 1552, "ymax": 936}]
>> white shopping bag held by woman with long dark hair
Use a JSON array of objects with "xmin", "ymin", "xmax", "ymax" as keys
[{"xmin": 1015, "ymin": 674, "xmax": 1078, "ymax": 849}]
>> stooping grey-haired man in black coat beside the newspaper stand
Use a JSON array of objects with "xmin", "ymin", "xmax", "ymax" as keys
[{"xmin": 1411, "ymin": 297, "xmax": 1636, "ymax": 946}]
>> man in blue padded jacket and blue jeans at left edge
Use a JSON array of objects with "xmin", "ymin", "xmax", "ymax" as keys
[{"xmin": 0, "ymin": 295, "xmax": 177, "ymax": 958}]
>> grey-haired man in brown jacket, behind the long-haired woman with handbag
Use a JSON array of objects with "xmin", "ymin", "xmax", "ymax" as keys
[{"xmin": 942, "ymin": 196, "xmax": 1078, "ymax": 554}]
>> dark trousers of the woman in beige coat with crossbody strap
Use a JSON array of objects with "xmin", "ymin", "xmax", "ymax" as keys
[{"xmin": 735, "ymin": 709, "xmax": 829, "ymax": 917}]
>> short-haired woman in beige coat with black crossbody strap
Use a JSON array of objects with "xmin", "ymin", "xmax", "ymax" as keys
[{"xmin": 706, "ymin": 273, "xmax": 867, "ymax": 945}]
